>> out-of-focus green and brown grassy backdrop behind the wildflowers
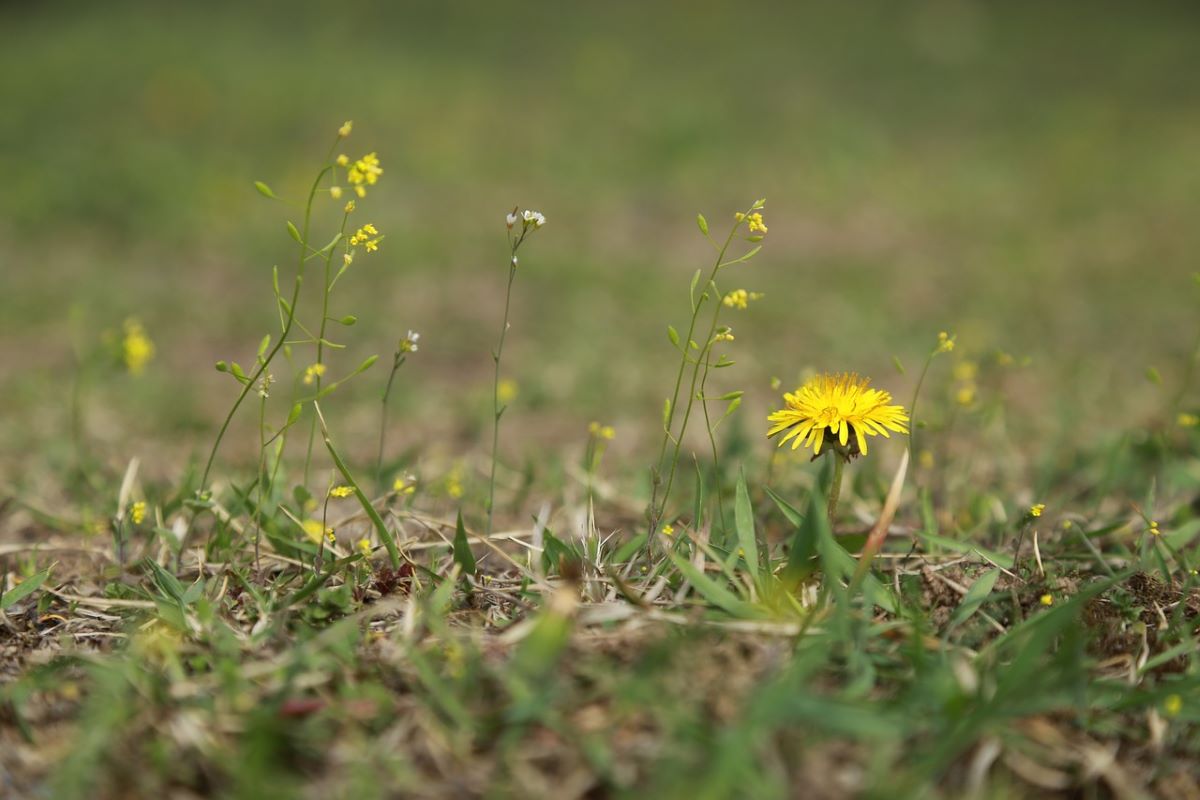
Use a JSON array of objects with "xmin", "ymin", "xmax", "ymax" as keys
[{"xmin": 0, "ymin": 0, "xmax": 1200, "ymax": 484}]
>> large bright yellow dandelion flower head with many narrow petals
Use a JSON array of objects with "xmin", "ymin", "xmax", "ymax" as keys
[{"xmin": 767, "ymin": 372, "xmax": 908, "ymax": 456}]
